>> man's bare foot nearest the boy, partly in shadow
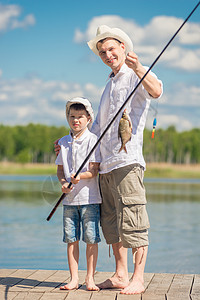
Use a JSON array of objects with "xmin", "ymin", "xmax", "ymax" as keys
[{"xmin": 97, "ymin": 274, "xmax": 129, "ymax": 289}]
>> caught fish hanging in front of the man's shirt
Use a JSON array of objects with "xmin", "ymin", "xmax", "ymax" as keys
[{"xmin": 118, "ymin": 109, "xmax": 132, "ymax": 153}]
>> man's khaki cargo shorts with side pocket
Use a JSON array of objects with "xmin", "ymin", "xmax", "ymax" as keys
[{"xmin": 99, "ymin": 164, "xmax": 150, "ymax": 248}]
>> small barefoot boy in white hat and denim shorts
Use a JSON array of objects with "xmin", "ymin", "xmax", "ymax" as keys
[{"xmin": 56, "ymin": 98, "xmax": 101, "ymax": 291}]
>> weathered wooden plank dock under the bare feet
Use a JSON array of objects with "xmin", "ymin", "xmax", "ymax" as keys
[{"xmin": 0, "ymin": 269, "xmax": 200, "ymax": 300}]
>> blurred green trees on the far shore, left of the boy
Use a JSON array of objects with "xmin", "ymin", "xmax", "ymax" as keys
[{"xmin": 0, "ymin": 124, "xmax": 69, "ymax": 163}]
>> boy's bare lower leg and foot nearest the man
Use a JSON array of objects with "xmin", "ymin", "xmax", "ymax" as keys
[{"xmin": 85, "ymin": 244, "xmax": 99, "ymax": 291}]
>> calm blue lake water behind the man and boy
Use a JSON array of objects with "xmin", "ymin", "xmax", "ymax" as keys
[{"xmin": 0, "ymin": 176, "xmax": 200, "ymax": 274}]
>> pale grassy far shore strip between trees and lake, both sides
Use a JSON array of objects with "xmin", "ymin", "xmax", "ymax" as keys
[{"xmin": 0, "ymin": 162, "xmax": 200, "ymax": 179}]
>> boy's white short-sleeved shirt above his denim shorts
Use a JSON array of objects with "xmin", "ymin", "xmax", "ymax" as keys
[{"xmin": 55, "ymin": 129, "xmax": 102, "ymax": 205}]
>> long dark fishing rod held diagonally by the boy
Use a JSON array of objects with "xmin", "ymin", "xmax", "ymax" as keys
[{"xmin": 47, "ymin": 1, "xmax": 200, "ymax": 221}]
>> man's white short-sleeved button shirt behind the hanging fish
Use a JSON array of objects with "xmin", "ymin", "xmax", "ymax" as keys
[{"xmin": 92, "ymin": 64, "xmax": 162, "ymax": 174}]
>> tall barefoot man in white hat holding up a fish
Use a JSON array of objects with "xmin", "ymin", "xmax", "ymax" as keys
[{"xmin": 88, "ymin": 25, "xmax": 162, "ymax": 294}]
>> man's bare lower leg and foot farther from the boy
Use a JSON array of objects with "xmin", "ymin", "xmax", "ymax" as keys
[{"xmin": 120, "ymin": 246, "xmax": 148, "ymax": 295}]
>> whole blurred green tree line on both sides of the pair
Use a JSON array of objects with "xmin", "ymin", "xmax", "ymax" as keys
[{"xmin": 0, "ymin": 124, "xmax": 200, "ymax": 164}]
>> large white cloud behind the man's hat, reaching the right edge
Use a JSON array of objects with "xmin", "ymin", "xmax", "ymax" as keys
[{"xmin": 74, "ymin": 15, "xmax": 200, "ymax": 72}]
